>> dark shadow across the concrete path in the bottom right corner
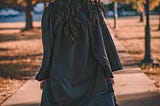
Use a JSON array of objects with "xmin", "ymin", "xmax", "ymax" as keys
[{"xmin": 117, "ymin": 92, "xmax": 160, "ymax": 106}]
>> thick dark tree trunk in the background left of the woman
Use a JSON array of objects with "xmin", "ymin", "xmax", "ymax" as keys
[{"xmin": 25, "ymin": 0, "xmax": 33, "ymax": 30}]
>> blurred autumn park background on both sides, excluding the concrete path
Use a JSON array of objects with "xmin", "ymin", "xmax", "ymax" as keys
[{"xmin": 0, "ymin": 0, "xmax": 160, "ymax": 104}]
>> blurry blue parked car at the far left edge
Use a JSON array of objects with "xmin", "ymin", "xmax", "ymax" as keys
[{"xmin": 0, "ymin": 8, "xmax": 20, "ymax": 17}]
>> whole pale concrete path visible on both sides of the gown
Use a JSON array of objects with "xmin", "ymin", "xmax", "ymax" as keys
[{"xmin": 2, "ymin": 24, "xmax": 160, "ymax": 106}]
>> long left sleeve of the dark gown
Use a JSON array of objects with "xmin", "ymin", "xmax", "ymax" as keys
[{"xmin": 36, "ymin": 8, "xmax": 54, "ymax": 81}]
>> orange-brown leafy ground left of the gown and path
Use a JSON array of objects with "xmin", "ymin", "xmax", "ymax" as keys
[{"xmin": 0, "ymin": 23, "xmax": 42, "ymax": 104}]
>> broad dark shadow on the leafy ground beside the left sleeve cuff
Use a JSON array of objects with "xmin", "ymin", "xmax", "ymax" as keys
[{"xmin": 0, "ymin": 54, "xmax": 42, "ymax": 80}]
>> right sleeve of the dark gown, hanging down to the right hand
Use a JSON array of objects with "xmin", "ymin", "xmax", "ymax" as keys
[{"xmin": 91, "ymin": 15, "xmax": 113, "ymax": 78}]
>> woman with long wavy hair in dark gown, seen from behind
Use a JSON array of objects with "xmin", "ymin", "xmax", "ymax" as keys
[{"xmin": 36, "ymin": 0, "xmax": 121, "ymax": 106}]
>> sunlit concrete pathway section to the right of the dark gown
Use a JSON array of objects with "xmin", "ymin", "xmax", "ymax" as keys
[{"xmin": 113, "ymin": 29, "xmax": 160, "ymax": 106}]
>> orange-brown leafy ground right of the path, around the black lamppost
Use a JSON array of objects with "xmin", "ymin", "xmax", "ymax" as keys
[{"xmin": 108, "ymin": 16, "xmax": 160, "ymax": 90}]
